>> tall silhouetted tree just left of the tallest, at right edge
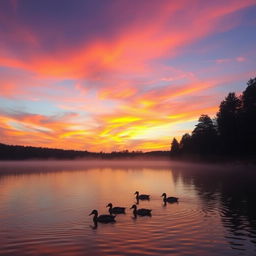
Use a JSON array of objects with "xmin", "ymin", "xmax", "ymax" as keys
[{"xmin": 217, "ymin": 92, "xmax": 242, "ymax": 153}]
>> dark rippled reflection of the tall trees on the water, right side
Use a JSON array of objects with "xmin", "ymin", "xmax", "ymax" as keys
[{"xmin": 172, "ymin": 165, "xmax": 256, "ymax": 252}]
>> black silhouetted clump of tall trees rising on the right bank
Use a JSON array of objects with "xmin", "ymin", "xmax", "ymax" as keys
[{"xmin": 171, "ymin": 77, "xmax": 256, "ymax": 157}]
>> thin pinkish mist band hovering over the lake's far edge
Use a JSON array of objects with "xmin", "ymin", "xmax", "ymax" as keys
[{"xmin": 0, "ymin": 158, "xmax": 255, "ymax": 174}]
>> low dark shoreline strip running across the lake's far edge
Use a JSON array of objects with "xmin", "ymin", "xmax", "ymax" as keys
[{"xmin": 0, "ymin": 143, "xmax": 256, "ymax": 165}]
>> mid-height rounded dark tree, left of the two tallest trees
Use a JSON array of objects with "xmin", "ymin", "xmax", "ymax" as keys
[{"xmin": 192, "ymin": 115, "xmax": 218, "ymax": 155}]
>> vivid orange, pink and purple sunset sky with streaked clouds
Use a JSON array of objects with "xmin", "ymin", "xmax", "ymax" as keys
[{"xmin": 0, "ymin": 0, "xmax": 256, "ymax": 152}]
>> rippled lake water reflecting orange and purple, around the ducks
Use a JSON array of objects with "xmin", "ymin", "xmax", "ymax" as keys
[{"xmin": 0, "ymin": 162, "xmax": 256, "ymax": 256}]
